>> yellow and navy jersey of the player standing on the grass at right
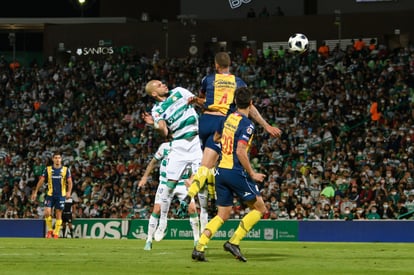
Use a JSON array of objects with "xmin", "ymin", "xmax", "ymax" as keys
[{"xmin": 218, "ymin": 112, "xmax": 254, "ymax": 170}]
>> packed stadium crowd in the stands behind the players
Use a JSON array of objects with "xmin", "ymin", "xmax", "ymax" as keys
[{"xmin": 0, "ymin": 38, "xmax": 414, "ymax": 223}]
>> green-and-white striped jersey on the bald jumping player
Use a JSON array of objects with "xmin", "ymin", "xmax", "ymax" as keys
[{"xmin": 151, "ymin": 87, "xmax": 198, "ymax": 140}]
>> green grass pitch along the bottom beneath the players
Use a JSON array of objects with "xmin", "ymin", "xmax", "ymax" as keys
[{"xmin": 0, "ymin": 238, "xmax": 414, "ymax": 275}]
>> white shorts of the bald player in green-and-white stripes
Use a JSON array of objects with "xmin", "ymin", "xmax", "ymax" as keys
[{"xmin": 166, "ymin": 136, "xmax": 203, "ymax": 181}]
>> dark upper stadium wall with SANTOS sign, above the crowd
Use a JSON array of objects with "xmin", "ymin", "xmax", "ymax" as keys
[{"xmin": 43, "ymin": 11, "xmax": 414, "ymax": 58}]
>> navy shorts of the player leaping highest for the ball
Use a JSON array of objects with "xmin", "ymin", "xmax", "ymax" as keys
[{"xmin": 198, "ymin": 114, "xmax": 226, "ymax": 154}]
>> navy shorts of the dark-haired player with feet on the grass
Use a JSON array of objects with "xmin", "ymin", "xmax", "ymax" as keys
[{"xmin": 216, "ymin": 168, "xmax": 261, "ymax": 206}]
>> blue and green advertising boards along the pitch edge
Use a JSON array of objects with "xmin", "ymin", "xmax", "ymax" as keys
[{"xmin": 0, "ymin": 219, "xmax": 414, "ymax": 243}]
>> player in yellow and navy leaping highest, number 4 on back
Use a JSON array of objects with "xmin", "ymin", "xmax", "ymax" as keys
[{"xmin": 185, "ymin": 52, "xmax": 281, "ymax": 207}]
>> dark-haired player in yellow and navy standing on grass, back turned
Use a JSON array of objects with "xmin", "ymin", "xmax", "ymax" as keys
[{"xmin": 192, "ymin": 87, "xmax": 266, "ymax": 262}]
